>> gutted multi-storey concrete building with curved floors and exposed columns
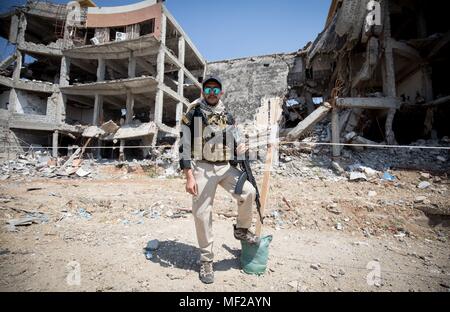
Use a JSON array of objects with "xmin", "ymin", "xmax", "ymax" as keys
[{"xmin": 0, "ymin": 0, "xmax": 206, "ymax": 159}]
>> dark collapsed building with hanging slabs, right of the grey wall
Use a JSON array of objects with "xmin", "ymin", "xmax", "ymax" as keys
[{"xmin": 289, "ymin": 0, "xmax": 450, "ymax": 156}]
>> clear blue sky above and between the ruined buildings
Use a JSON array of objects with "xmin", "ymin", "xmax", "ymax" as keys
[{"xmin": 0, "ymin": 0, "xmax": 331, "ymax": 61}]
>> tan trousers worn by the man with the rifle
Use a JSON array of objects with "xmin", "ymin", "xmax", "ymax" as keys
[{"xmin": 192, "ymin": 161, "xmax": 256, "ymax": 262}]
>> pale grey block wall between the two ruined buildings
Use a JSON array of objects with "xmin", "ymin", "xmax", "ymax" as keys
[{"xmin": 207, "ymin": 54, "xmax": 295, "ymax": 122}]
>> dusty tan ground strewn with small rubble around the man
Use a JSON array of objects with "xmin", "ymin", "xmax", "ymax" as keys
[{"xmin": 0, "ymin": 168, "xmax": 450, "ymax": 291}]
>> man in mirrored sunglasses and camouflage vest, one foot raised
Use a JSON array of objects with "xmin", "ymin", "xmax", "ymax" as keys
[{"xmin": 180, "ymin": 77, "xmax": 258, "ymax": 284}]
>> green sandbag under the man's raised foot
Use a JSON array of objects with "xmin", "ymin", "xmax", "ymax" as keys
[{"xmin": 241, "ymin": 235, "xmax": 273, "ymax": 275}]
